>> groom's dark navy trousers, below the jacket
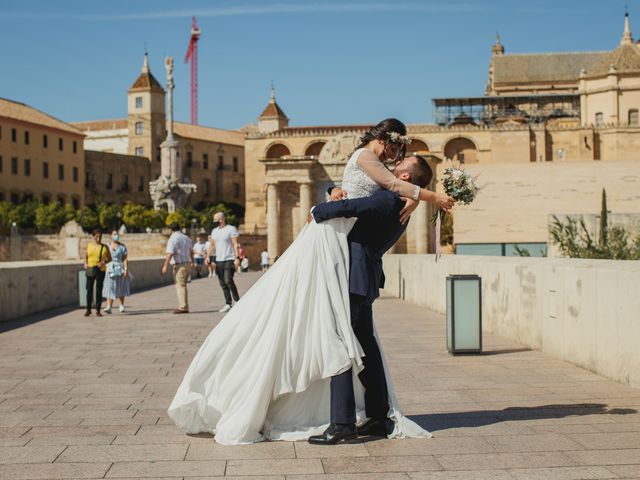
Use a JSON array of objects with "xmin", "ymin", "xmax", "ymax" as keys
[{"xmin": 331, "ymin": 293, "xmax": 389, "ymax": 423}]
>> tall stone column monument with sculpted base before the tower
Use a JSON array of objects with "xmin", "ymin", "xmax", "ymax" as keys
[{"xmin": 149, "ymin": 57, "xmax": 196, "ymax": 213}]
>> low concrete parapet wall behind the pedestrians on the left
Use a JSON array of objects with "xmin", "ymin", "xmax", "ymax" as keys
[{"xmin": 0, "ymin": 257, "xmax": 173, "ymax": 322}]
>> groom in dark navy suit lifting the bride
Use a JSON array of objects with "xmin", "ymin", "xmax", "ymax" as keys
[{"xmin": 309, "ymin": 156, "xmax": 433, "ymax": 445}]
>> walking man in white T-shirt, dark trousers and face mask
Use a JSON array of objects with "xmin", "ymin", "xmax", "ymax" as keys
[{"xmin": 209, "ymin": 212, "xmax": 240, "ymax": 313}]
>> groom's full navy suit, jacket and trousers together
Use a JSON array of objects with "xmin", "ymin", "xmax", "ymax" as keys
[{"xmin": 313, "ymin": 190, "xmax": 406, "ymax": 424}]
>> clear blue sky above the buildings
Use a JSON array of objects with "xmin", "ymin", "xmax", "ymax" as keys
[{"xmin": 0, "ymin": 0, "xmax": 640, "ymax": 128}]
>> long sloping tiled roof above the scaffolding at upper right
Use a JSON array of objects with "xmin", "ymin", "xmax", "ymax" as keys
[{"xmin": 493, "ymin": 52, "xmax": 610, "ymax": 84}]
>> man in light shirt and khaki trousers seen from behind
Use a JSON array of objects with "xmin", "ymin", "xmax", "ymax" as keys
[{"xmin": 162, "ymin": 223, "xmax": 193, "ymax": 313}]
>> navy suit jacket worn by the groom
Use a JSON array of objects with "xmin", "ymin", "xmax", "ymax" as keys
[{"xmin": 313, "ymin": 190, "xmax": 407, "ymax": 302}]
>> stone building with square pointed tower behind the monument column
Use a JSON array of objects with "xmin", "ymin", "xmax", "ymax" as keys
[{"xmin": 74, "ymin": 54, "xmax": 245, "ymax": 206}]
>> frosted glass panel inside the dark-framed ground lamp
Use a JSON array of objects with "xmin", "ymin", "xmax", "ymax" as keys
[{"xmin": 453, "ymin": 279, "xmax": 480, "ymax": 350}]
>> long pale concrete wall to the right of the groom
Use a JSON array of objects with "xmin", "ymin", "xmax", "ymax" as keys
[{"xmin": 384, "ymin": 255, "xmax": 640, "ymax": 387}]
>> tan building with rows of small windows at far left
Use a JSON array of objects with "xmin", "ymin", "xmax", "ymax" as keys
[{"xmin": 0, "ymin": 99, "xmax": 85, "ymax": 208}]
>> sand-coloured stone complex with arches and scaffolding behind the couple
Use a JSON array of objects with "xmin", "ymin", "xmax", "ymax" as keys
[{"xmin": 244, "ymin": 16, "xmax": 640, "ymax": 258}]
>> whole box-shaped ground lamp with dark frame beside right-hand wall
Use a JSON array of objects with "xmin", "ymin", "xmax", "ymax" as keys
[{"xmin": 447, "ymin": 275, "xmax": 482, "ymax": 355}]
